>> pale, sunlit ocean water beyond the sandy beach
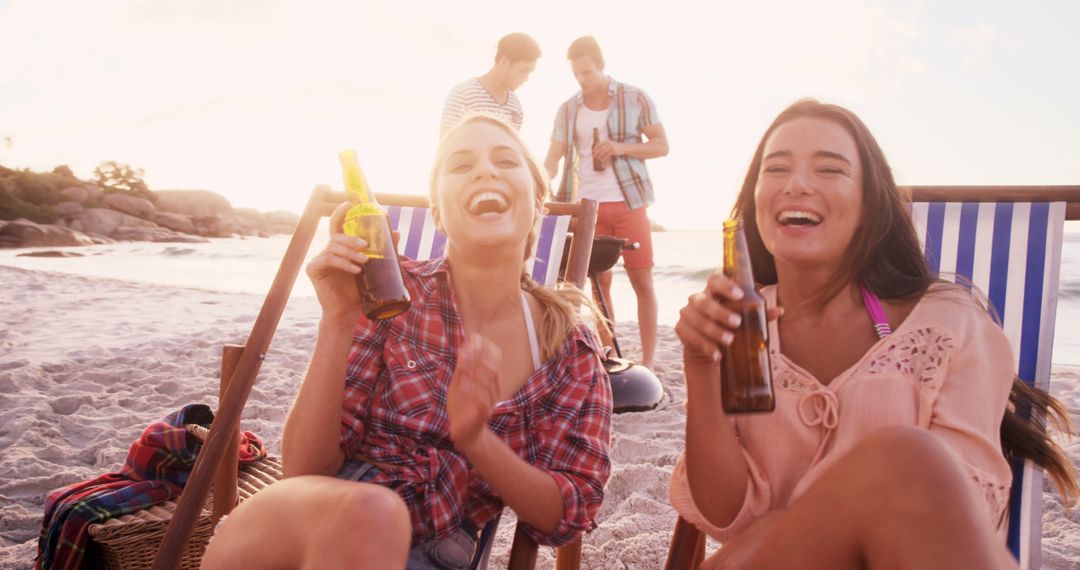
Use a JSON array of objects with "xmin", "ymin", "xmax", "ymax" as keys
[{"xmin": 0, "ymin": 222, "xmax": 1080, "ymax": 365}]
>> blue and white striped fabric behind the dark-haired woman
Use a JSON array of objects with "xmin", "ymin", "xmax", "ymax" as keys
[{"xmin": 912, "ymin": 202, "xmax": 1065, "ymax": 569}]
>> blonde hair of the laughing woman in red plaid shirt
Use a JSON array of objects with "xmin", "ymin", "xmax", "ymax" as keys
[{"xmin": 428, "ymin": 114, "xmax": 606, "ymax": 361}]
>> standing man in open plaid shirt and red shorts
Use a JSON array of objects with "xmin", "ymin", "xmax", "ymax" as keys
[{"xmin": 544, "ymin": 36, "xmax": 667, "ymax": 368}]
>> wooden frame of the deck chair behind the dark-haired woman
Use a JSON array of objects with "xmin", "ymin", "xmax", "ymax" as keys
[{"xmin": 664, "ymin": 186, "xmax": 1080, "ymax": 570}]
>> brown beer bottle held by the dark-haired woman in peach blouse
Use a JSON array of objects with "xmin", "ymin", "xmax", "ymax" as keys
[{"xmin": 720, "ymin": 219, "xmax": 777, "ymax": 413}]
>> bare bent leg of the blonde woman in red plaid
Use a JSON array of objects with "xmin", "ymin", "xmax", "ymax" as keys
[{"xmin": 202, "ymin": 476, "xmax": 410, "ymax": 570}]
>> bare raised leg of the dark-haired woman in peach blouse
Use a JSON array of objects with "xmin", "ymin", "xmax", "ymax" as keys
[{"xmin": 721, "ymin": 428, "xmax": 1016, "ymax": 570}]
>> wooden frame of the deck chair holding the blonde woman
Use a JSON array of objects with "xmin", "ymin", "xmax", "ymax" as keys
[{"xmin": 152, "ymin": 186, "xmax": 597, "ymax": 570}]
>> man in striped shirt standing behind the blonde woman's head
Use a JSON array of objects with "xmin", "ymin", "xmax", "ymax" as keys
[{"xmin": 441, "ymin": 32, "xmax": 540, "ymax": 133}]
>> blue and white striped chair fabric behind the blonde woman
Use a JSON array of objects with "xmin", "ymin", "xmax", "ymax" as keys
[{"xmin": 387, "ymin": 206, "xmax": 570, "ymax": 286}]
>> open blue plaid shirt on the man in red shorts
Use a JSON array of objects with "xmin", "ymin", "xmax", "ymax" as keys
[{"xmin": 551, "ymin": 78, "xmax": 660, "ymax": 209}]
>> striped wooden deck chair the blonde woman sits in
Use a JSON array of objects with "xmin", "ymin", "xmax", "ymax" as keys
[{"xmin": 145, "ymin": 186, "xmax": 597, "ymax": 570}]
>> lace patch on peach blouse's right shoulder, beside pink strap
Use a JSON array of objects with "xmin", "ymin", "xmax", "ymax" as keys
[{"xmin": 866, "ymin": 327, "xmax": 955, "ymax": 388}]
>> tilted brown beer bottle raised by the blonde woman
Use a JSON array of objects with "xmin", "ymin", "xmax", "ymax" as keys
[{"xmin": 338, "ymin": 150, "xmax": 409, "ymax": 320}]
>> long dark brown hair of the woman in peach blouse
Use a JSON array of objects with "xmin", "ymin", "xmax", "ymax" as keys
[{"xmin": 732, "ymin": 99, "xmax": 1080, "ymax": 505}]
